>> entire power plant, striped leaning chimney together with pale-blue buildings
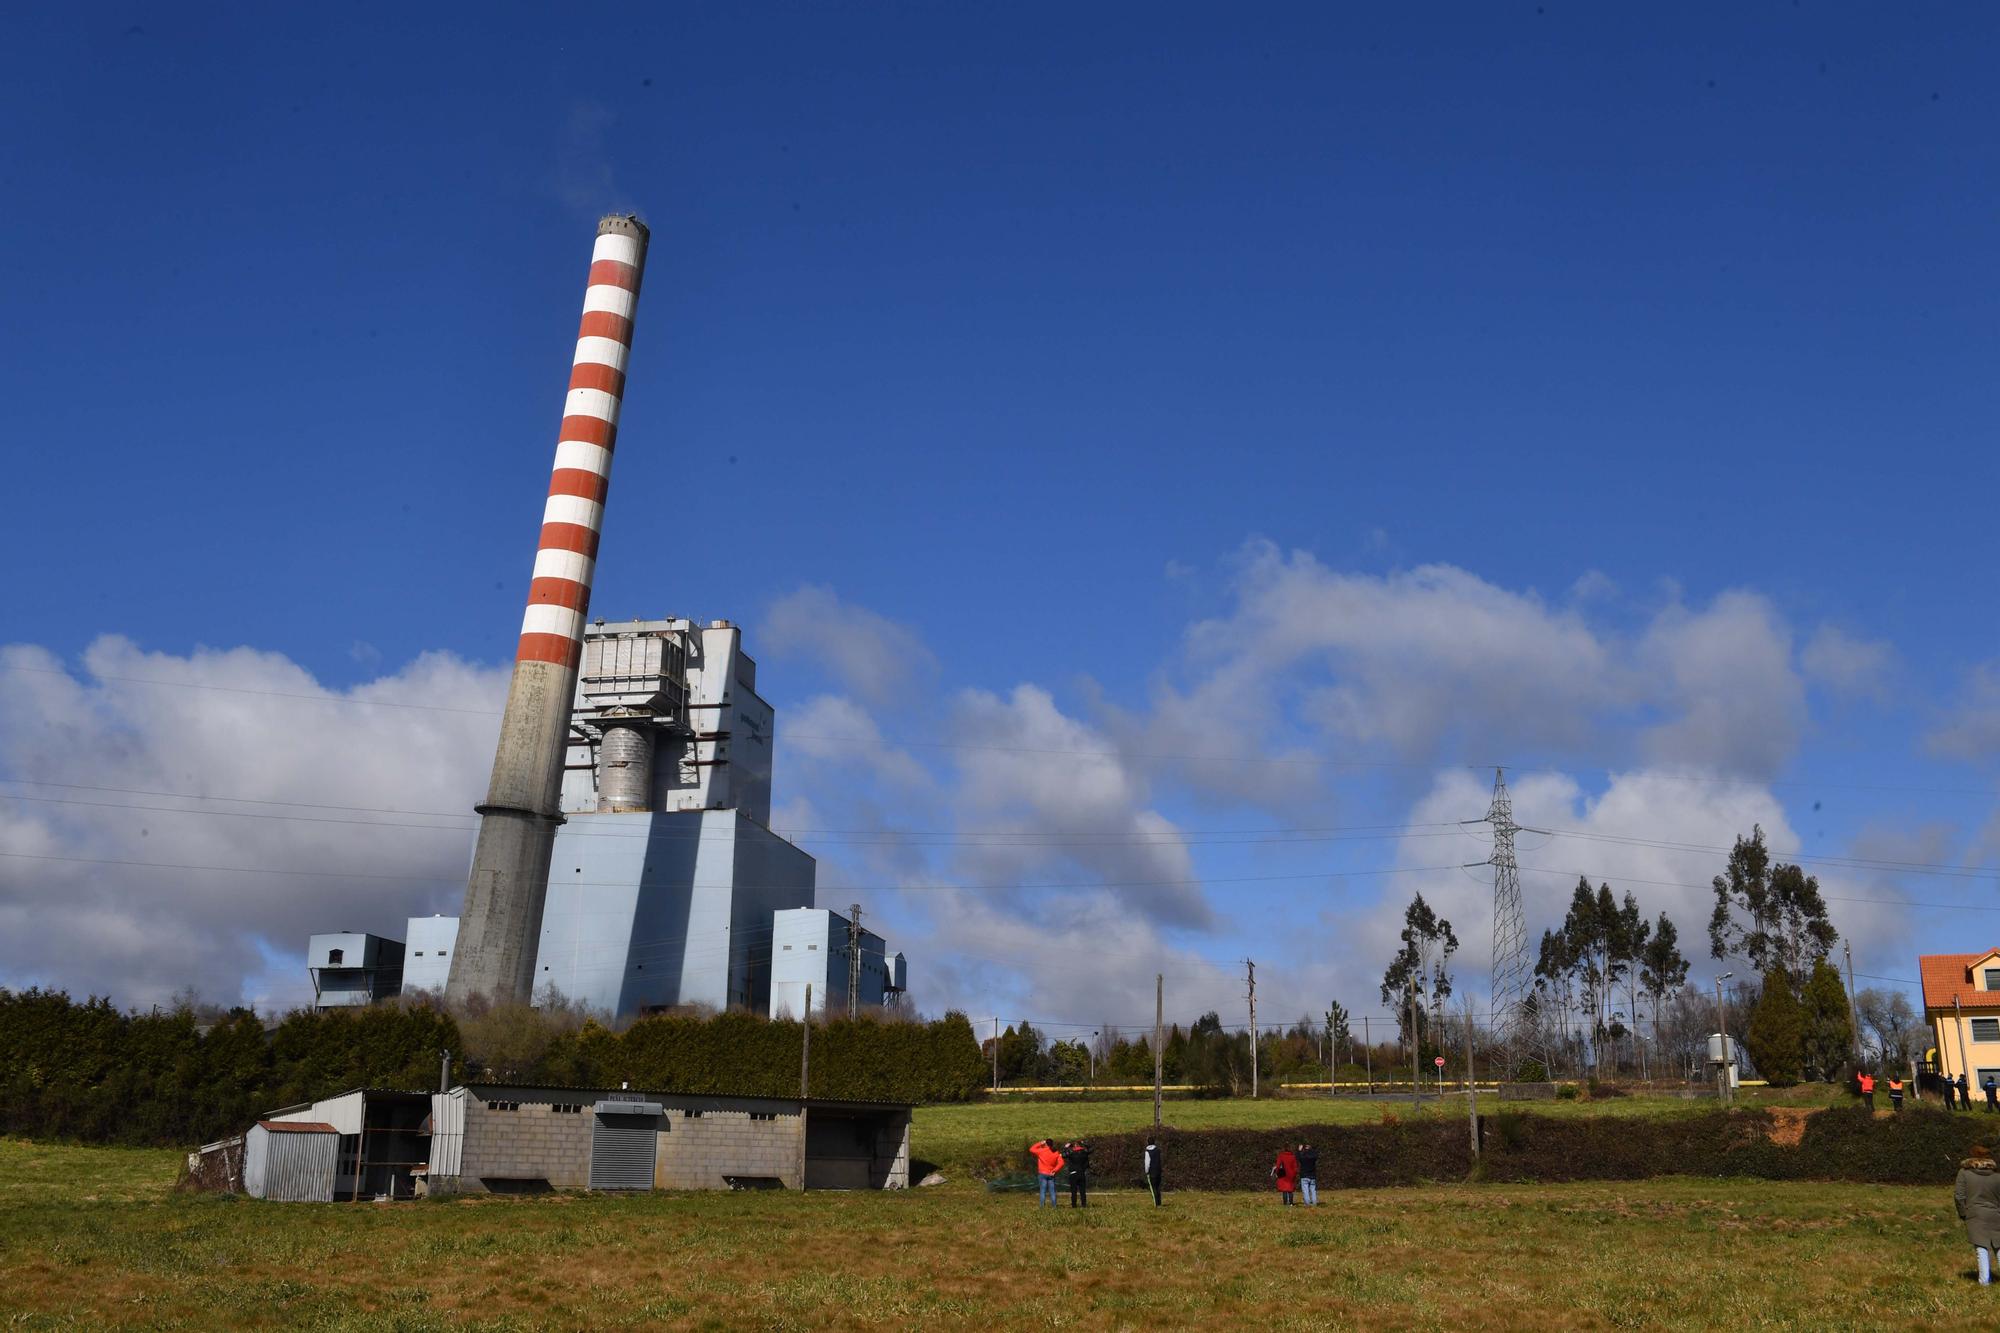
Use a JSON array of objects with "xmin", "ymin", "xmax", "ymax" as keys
[{"xmin": 308, "ymin": 223, "xmax": 902, "ymax": 1019}]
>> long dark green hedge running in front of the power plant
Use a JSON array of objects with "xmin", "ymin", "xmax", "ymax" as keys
[{"xmin": 0, "ymin": 989, "xmax": 986, "ymax": 1145}]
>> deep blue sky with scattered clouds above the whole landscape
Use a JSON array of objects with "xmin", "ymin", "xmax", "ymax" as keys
[{"xmin": 0, "ymin": 4, "xmax": 2000, "ymax": 1017}]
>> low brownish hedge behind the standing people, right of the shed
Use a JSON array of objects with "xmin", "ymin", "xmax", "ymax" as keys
[{"xmin": 1048, "ymin": 1107, "xmax": 2000, "ymax": 1189}]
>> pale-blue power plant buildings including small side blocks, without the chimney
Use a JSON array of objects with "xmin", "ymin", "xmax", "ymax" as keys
[{"xmin": 308, "ymin": 618, "xmax": 908, "ymax": 1019}]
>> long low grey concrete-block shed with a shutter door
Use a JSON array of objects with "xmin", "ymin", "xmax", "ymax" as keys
[{"xmin": 428, "ymin": 1083, "xmax": 910, "ymax": 1193}]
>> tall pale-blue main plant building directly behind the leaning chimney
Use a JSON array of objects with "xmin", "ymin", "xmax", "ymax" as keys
[{"xmin": 534, "ymin": 620, "xmax": 814, "ymax": 1015}]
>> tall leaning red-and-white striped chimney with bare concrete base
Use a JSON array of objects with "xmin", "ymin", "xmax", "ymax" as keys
[{"xmin": 446, "ymin": 216, "xmax": 648, "ymax": 1003}]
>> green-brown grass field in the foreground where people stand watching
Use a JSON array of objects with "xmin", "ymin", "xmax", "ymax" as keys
[{"xmin": 0, "ymin": 1103, "xmax": 1968, "ymax": 1331}]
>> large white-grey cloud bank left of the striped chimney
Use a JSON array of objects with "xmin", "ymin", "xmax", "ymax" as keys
[{"xmin": 0, "ymin": 636, "xmax": 506, "ymax": 1003}]
